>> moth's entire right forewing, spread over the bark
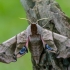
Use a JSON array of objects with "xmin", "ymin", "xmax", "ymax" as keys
[{"xmin": 42, "ymin": 29, "xmax": 70, "ymax": 58}]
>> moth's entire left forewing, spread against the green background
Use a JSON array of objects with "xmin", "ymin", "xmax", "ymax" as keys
[{"xmin": 0, "ymin": 31, "xmax": 27, "ymax": 63}]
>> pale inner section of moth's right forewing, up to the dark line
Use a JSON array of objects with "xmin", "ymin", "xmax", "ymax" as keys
[{"xmin": 42, "ymin": 29, "xmax": 57, "ymax": 53}]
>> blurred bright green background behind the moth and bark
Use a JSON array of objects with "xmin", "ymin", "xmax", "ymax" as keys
[{"xmin": 0, "ymin": 0, "xmax": 70, "ymax": 70}]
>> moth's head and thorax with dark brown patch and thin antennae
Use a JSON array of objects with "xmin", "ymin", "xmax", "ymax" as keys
[{"xmin": 20, "ymin": 18, "xmax": 48, "ymax": 36}]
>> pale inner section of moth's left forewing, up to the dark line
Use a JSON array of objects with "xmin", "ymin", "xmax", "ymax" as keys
[{"xmin": 15, "ymin": 30, "xmax": 28, "ymax": 54}]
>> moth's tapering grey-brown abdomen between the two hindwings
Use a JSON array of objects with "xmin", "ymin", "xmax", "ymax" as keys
[{"xmin": 29, "ymin": 34, "xmax": 43, "ymax": 64}]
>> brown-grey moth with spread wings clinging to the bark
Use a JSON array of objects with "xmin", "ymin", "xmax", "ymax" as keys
[{"xmin": 0, "ymin": 18, "xmax": 70, "ymax": 65}]
